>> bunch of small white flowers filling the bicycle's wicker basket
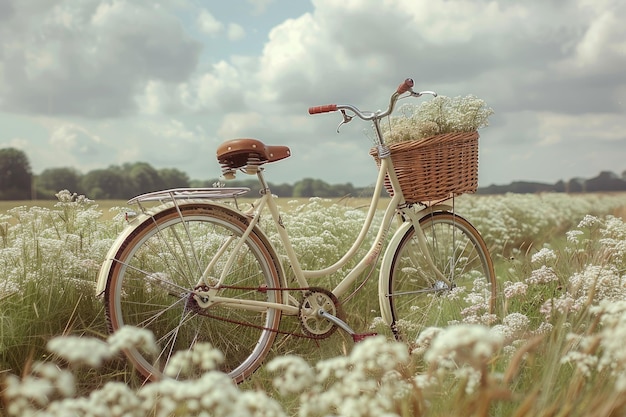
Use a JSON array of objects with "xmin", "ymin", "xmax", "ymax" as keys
[{"xmin": 383, "ymin": 95, "xmax": 493, "ymax": 145}]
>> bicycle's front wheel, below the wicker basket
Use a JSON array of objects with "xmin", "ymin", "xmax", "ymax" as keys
[{"xmin": 387, "ymin": 212, "xmax": 496, "ymax": 343}]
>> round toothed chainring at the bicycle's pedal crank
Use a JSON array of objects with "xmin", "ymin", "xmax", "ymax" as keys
[{"xmin": 298, "ymin": 287, "xmax": 343, "ymax": 339}]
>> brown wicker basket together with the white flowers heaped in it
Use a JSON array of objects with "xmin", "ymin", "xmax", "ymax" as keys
[{"xmin": 370, "ymin": 96, "xmax": 493, "ymax": 204}]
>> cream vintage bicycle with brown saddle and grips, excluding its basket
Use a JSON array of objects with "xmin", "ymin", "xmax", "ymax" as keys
[{"xmin": 96, "ymin": 79, "xmax": 496, "ymax": 382}]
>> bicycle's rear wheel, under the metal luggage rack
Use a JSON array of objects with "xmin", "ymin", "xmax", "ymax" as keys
[{"xmin": 105, "ymin": 203, "xmax": 281, "ymax": 382}]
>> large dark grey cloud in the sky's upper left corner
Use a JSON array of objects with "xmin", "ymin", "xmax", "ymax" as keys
[{"xmin": 0, "ymin": 0, "xmax": 200, "ymax": 117}]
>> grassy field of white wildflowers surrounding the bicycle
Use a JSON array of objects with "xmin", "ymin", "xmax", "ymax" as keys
[{"xmin": 0, "ymin": 192, "xmax": 626, "ymax": 417}]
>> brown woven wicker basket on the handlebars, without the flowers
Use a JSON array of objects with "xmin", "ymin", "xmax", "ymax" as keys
[{"xmin": 370, "ymin": 132, "xmax": 478, "ymax": 203}]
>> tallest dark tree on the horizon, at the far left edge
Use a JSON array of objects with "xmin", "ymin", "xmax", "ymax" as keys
[{"xmin": 0, "ymin": 148, "xmax": 33, "ymax": 200}]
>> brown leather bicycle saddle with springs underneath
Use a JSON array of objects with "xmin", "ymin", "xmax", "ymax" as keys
[{"xmin": 217, "ymin": 139, "xmax": 291, "ymax": 174}]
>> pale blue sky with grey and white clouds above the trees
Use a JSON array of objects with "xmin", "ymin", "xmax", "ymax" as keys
[{"xmin": 0, "ymin": 0, "xmax": 626, "ymax": 186}]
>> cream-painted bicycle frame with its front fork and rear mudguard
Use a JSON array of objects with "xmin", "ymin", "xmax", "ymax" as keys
[{"xmin": 96, "ymin": 150, "xmax": 452, "ymax": 324}]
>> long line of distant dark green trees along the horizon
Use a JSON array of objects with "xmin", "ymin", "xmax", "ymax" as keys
[{"xmin": 0, "ymin": 148, "xmax": 626, "ymax": 200}]
